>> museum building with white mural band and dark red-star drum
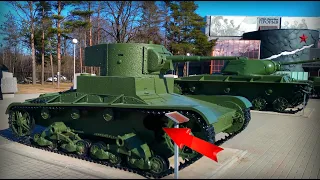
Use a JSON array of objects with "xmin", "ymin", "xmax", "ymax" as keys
[{"xmin": 176, "ymin": 16, "xmax": 320, "ymax": 76}]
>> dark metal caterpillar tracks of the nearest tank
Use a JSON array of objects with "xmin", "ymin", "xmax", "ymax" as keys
[{"xmin": 4, "ymin": 106, "xmax": 251, "ymax": 179}]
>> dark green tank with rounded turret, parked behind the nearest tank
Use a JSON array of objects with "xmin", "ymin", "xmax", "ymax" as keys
[{"xmin": 173, "ymin": 56, "xmax": 320, "ymax": 113}]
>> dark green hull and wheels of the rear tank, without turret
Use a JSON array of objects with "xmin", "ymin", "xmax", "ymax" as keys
[{"xmin": 175, "ymin": 75, "xmax": 312, "ymax": 112}]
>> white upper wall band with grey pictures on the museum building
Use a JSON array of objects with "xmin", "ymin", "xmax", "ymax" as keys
[{"xmin": 205, "ymin": 15, "xmax": 320, "ymax": 39}]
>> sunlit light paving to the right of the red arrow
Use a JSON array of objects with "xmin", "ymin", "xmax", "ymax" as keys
[{"xmin": 214, "ymin": 99, "xmax": 320, "ymax": 179}]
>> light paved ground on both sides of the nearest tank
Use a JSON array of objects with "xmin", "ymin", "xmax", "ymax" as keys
[{"xmin": 0, "ymin": 95, "xmax": 320, "ymax": 179}]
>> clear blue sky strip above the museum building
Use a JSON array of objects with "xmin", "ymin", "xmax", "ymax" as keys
[{"xmin": 196, "ymin": 1, "xmax": 320, "ymax": 18}]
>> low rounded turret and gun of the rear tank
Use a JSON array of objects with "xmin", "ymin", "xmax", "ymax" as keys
[{"xmin": 221, "ymin": 58, "xmax": 320, "ymax": 75}]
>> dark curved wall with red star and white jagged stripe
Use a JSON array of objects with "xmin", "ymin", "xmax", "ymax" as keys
[{"xmin": 243, "ymin": 29, "xmax": 319, "ymax": 71}]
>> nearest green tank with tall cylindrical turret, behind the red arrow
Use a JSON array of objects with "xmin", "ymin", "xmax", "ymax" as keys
[{"xmin": 6, "ymin": 43, "xmax": 252, "ymax": 178}]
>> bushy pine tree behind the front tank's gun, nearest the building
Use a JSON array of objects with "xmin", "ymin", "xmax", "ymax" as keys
[{"xmin": 167, "ymin": 1, "xmax": 214, "ymax": 55}]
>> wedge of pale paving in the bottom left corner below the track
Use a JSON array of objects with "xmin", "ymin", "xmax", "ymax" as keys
[{"xmin": 0, "ymin": 138, "xmax": 140, "ymax": 179}]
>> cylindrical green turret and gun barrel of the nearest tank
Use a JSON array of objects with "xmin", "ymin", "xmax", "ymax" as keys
[{"xmin": 85, "ymin": 43, "xmax": 247, "ymax": 77}]
